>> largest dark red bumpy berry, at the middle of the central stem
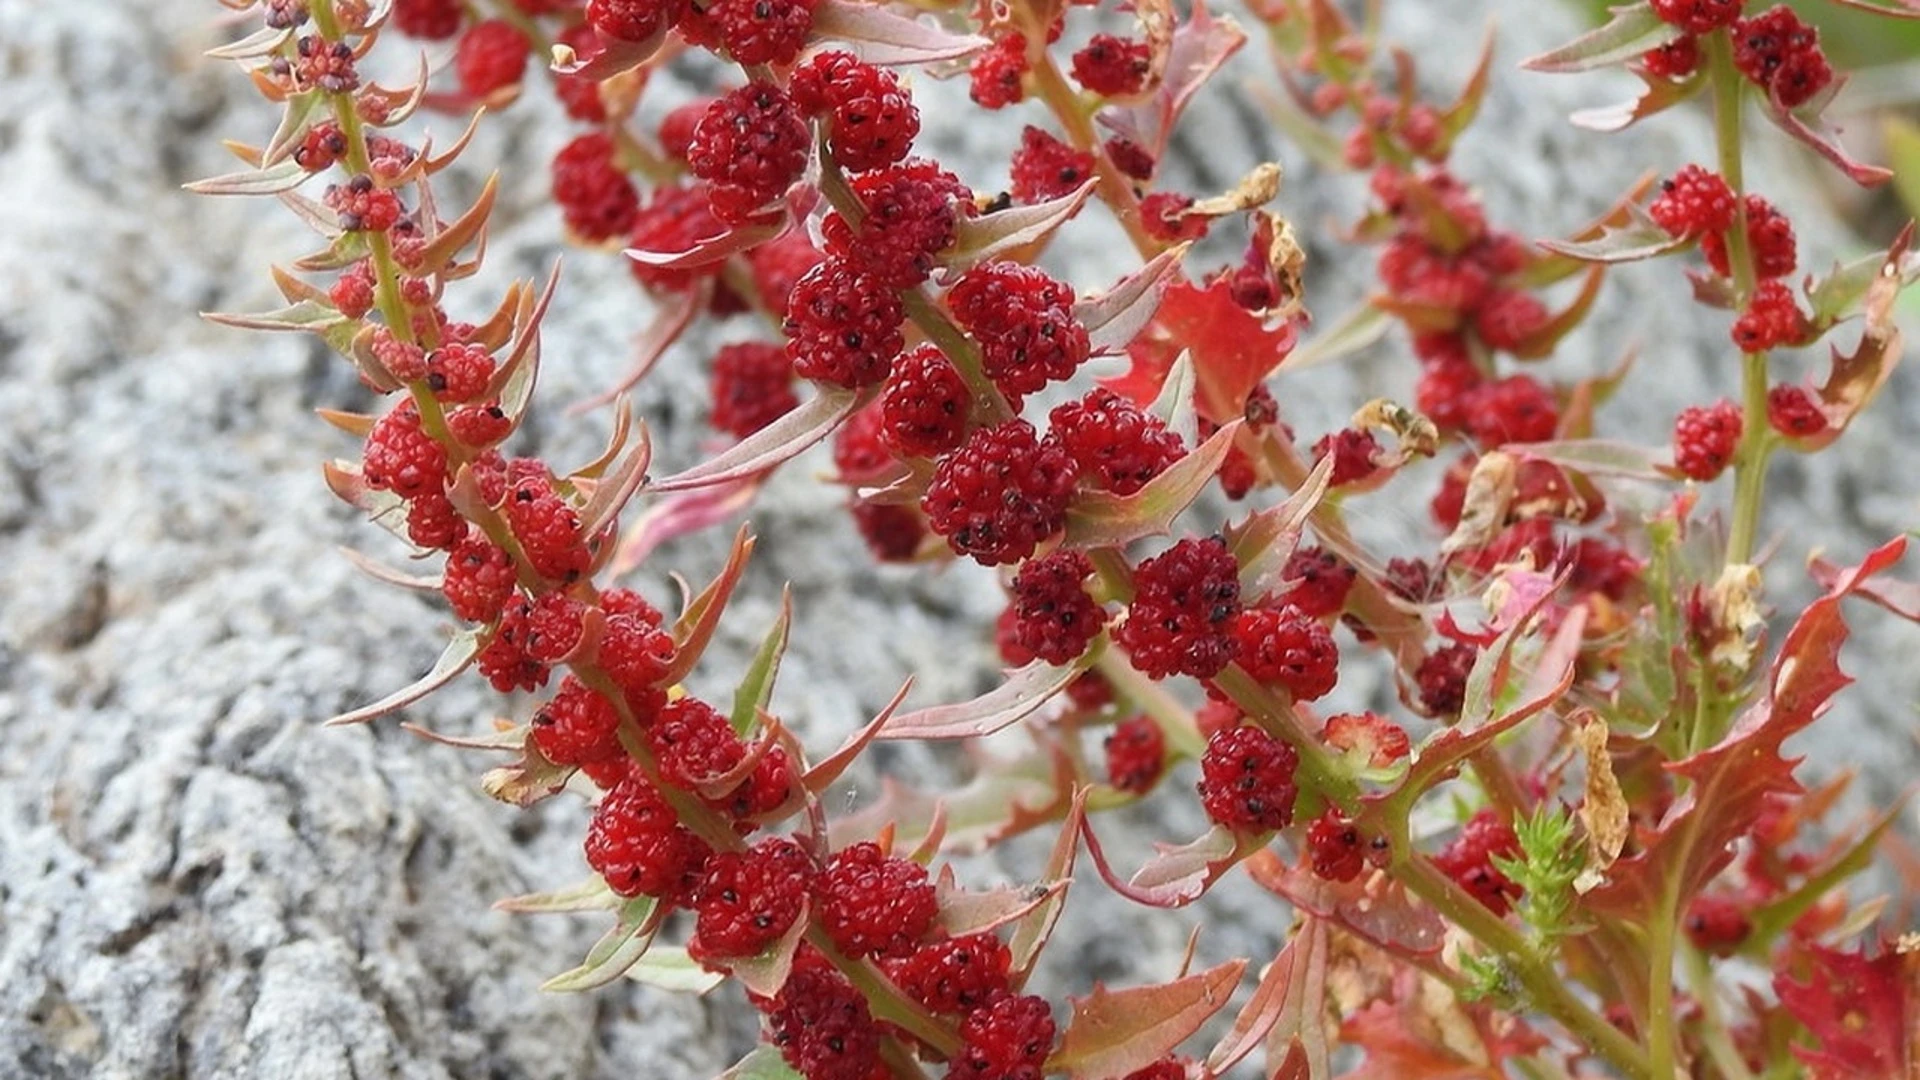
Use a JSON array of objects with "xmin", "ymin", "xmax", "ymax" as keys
[{"xmin": 920, "ymin": 417, "xmax": 1075, "ymax": 567}]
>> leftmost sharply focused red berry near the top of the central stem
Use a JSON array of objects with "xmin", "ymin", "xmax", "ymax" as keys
[{"xmin": 687, "ymin": 82, "xmax": 810, "ymax": 225}]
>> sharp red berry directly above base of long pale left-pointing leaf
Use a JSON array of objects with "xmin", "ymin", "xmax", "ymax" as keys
[{"xmin": 785, "ymin": 259, "xmax": 906, "ymax": 386}]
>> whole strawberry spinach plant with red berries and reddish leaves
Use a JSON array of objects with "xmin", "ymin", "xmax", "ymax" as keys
[{"xmin": 192, "ymin": 0, "xmax": 1920, "ymax": 1080}]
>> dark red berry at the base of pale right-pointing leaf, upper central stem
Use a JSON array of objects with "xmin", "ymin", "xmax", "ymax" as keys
[{"xmin": 820, "ymin": 158, "xmax": 973, "ymax": 288}]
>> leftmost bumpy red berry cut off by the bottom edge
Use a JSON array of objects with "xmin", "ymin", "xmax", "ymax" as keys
[{"xmin": 766, "ymin": 947, "xmax": 885, "ymax": 1080}]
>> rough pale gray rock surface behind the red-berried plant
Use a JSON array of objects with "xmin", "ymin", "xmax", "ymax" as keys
[{"xmin": 0, "ymin": 0, "xmax": 1920, "ymax": 1080}]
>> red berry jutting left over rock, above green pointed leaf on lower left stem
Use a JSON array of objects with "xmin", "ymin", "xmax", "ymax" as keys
[{"xmin": 586, "ymin": 776, "xmax": 712, "ymax": 903}]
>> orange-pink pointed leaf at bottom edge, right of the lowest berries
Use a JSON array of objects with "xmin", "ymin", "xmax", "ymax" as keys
[{"xmin": 1046, "ymin": 961, "xmax": 1246, "ymax": 1080}]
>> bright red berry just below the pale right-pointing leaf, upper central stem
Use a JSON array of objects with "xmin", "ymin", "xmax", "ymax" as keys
[{"xmin": 947, "ymin": 261, "xmax": 1092, "ymax": 400}]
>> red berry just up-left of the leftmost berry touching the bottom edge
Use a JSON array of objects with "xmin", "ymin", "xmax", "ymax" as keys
[{"xmin": 687, "ymin": 836, "xmax": 814, "ymax": 965}]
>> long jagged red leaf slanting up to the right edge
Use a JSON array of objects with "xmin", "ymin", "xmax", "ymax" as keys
[{"xmin": 1588, "ymin": 538, "xmax": 1907, "ymax": 915}]
